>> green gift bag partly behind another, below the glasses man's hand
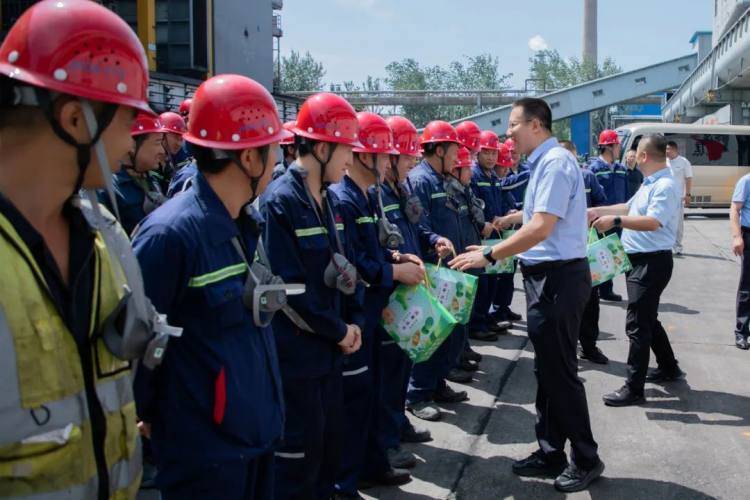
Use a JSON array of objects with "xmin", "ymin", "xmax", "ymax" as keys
[{"xmin": 425, "ymin": 260, "xmax": 478, "ymax": 325}]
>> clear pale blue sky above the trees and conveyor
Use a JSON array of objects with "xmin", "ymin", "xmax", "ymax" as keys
[{"xmin": 281, "ymin": 0, "xmax": 713, "ymax": 88}]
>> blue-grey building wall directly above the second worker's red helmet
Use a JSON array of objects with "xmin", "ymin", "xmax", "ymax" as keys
[{"xmin": 213, "ymin": 0, "xmax": 273, "ymax": 91}]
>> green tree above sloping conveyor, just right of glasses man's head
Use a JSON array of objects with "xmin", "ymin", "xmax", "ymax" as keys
[{"xmin": 529, "ymin": 50, "xmax": 622, "ymax": 149}]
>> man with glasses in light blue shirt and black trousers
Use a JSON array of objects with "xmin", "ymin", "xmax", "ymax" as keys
[{"xmin": 450, "ymin": 98, "xmax": 604, "ymax": 492}]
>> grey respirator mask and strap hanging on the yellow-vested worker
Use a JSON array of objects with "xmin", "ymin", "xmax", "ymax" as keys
[{"xmin": 75, "ymin": 191, "xmax": 182, "ymax": 369}]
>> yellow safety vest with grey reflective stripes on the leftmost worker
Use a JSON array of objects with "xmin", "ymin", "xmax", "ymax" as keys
[{"xmin": 0, "ymin": 214, "xmax": 141, "ymax": 500}]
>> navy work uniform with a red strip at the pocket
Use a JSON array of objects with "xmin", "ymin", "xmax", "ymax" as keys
[{"xmin": 133, "ymin": 174, "xmax": 284, "ymax": 499}]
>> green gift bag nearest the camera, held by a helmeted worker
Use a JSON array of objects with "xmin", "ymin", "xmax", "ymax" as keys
[{"xmin": 381, "ymin": 285, "xmax": 456, "ymax": 363}]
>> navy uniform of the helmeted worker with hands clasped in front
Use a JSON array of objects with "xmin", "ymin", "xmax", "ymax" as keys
[{"xmin": 260, "ymin": 164, "xmax": 365, "ymax": 499}]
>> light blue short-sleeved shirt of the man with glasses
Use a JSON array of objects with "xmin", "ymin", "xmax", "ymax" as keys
[{"xmin": 519, "ymin": 137, "xmax": 587, "ymax": 265}]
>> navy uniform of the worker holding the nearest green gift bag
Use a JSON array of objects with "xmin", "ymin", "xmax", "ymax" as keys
[{"xmin": 331, "ymin": 175, "xmax": 393, "ymax": 494}]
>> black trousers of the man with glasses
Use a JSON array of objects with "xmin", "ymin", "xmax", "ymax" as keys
[{"xmin": 522, "ymin": 259, "xmax": 598, "ymax": 469}]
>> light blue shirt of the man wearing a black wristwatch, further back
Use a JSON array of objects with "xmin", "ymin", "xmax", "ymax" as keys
[{"xmin": 621, "ymin": 167, "xmax": 681, "ymax": 253}]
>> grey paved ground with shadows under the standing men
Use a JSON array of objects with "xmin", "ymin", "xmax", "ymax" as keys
[{"xmin": 362, "ymin": 210, "xmax": 750, "ymax": 500}]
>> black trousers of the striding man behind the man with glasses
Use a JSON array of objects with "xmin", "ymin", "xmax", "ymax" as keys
[{"xmin": 625, "ymin": 250, "xmax": 677, "ymax": 393}]
